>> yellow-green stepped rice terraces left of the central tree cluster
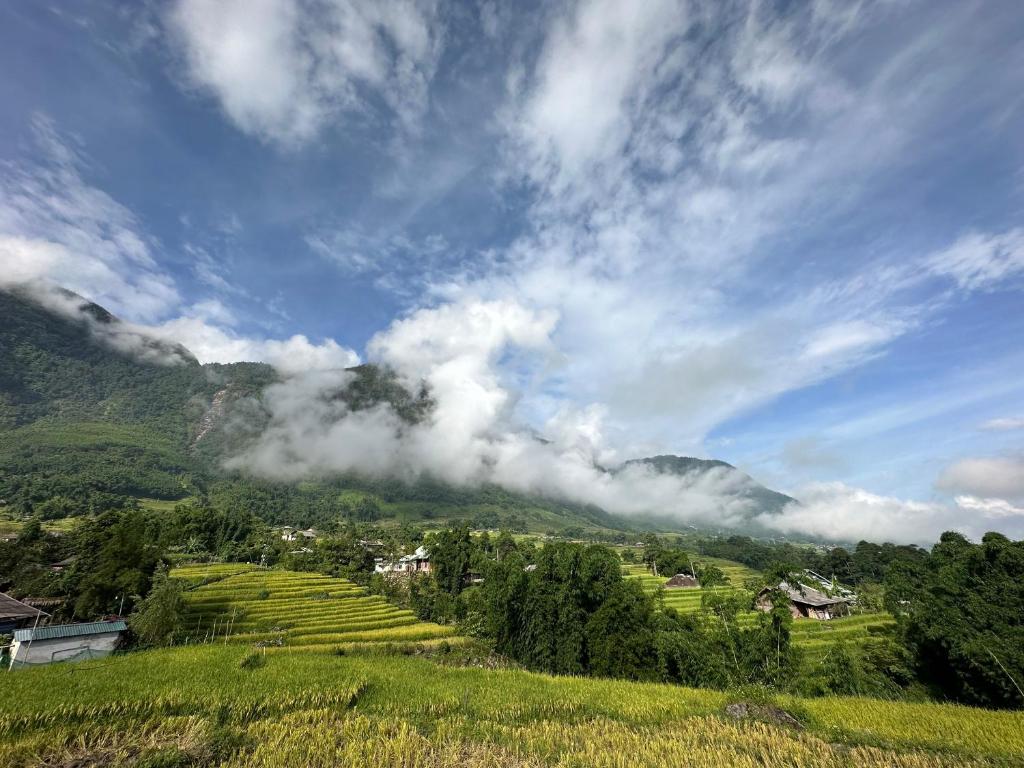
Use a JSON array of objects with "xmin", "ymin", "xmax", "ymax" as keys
[{"xmin": 171, "ymin": 564, "xmax": 455, "ymax": 650}]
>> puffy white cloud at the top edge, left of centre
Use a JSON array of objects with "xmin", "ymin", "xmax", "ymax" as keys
[{"xmin": 168, "ymin": 0, "xmax": 443, "ymax": 144}]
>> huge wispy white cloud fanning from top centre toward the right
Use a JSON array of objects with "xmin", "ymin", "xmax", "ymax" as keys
[{"xmin": 471, "ymin": 0, "xmax": 974, "ymax": 445}]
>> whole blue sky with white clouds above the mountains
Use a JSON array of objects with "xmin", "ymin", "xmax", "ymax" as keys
[{"xmin": 0, "ymin": 0, "xmax": 1024, "ymax": 542}]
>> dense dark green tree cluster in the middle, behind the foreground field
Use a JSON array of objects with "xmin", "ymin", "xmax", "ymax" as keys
[{"xmin": 411, "ymin": 529, "xmax": 799, "ymax": 688}]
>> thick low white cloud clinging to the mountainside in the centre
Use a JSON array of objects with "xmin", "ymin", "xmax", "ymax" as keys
[{"xmin": 229, "ymin": 301, "xmax": 765, "ymax": 524}]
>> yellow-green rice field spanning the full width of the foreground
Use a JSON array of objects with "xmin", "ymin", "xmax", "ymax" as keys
[{"xmin": 0, "ymin": 644, "xmax": 1024, "ymax": 768}]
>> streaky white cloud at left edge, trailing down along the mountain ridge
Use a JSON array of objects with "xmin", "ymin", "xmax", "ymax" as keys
[{"xmin": 0, "ymin": 118, "xmax": 359, "ymax": 372}]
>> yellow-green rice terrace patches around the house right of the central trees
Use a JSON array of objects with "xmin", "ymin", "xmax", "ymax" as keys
[{"xmin": 623, "ymin": 558, "xmax": 894, "ymax": 662}]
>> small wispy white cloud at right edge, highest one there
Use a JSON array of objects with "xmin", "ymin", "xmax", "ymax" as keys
[{"xmin": 927, "ymin": 228, "xmax": 1024, "ymax": 291}]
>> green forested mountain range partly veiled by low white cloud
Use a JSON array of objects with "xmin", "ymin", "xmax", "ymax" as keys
[{"xmin": 0, "ymin": 289, "xmax": 792, "ymax": 532}]
